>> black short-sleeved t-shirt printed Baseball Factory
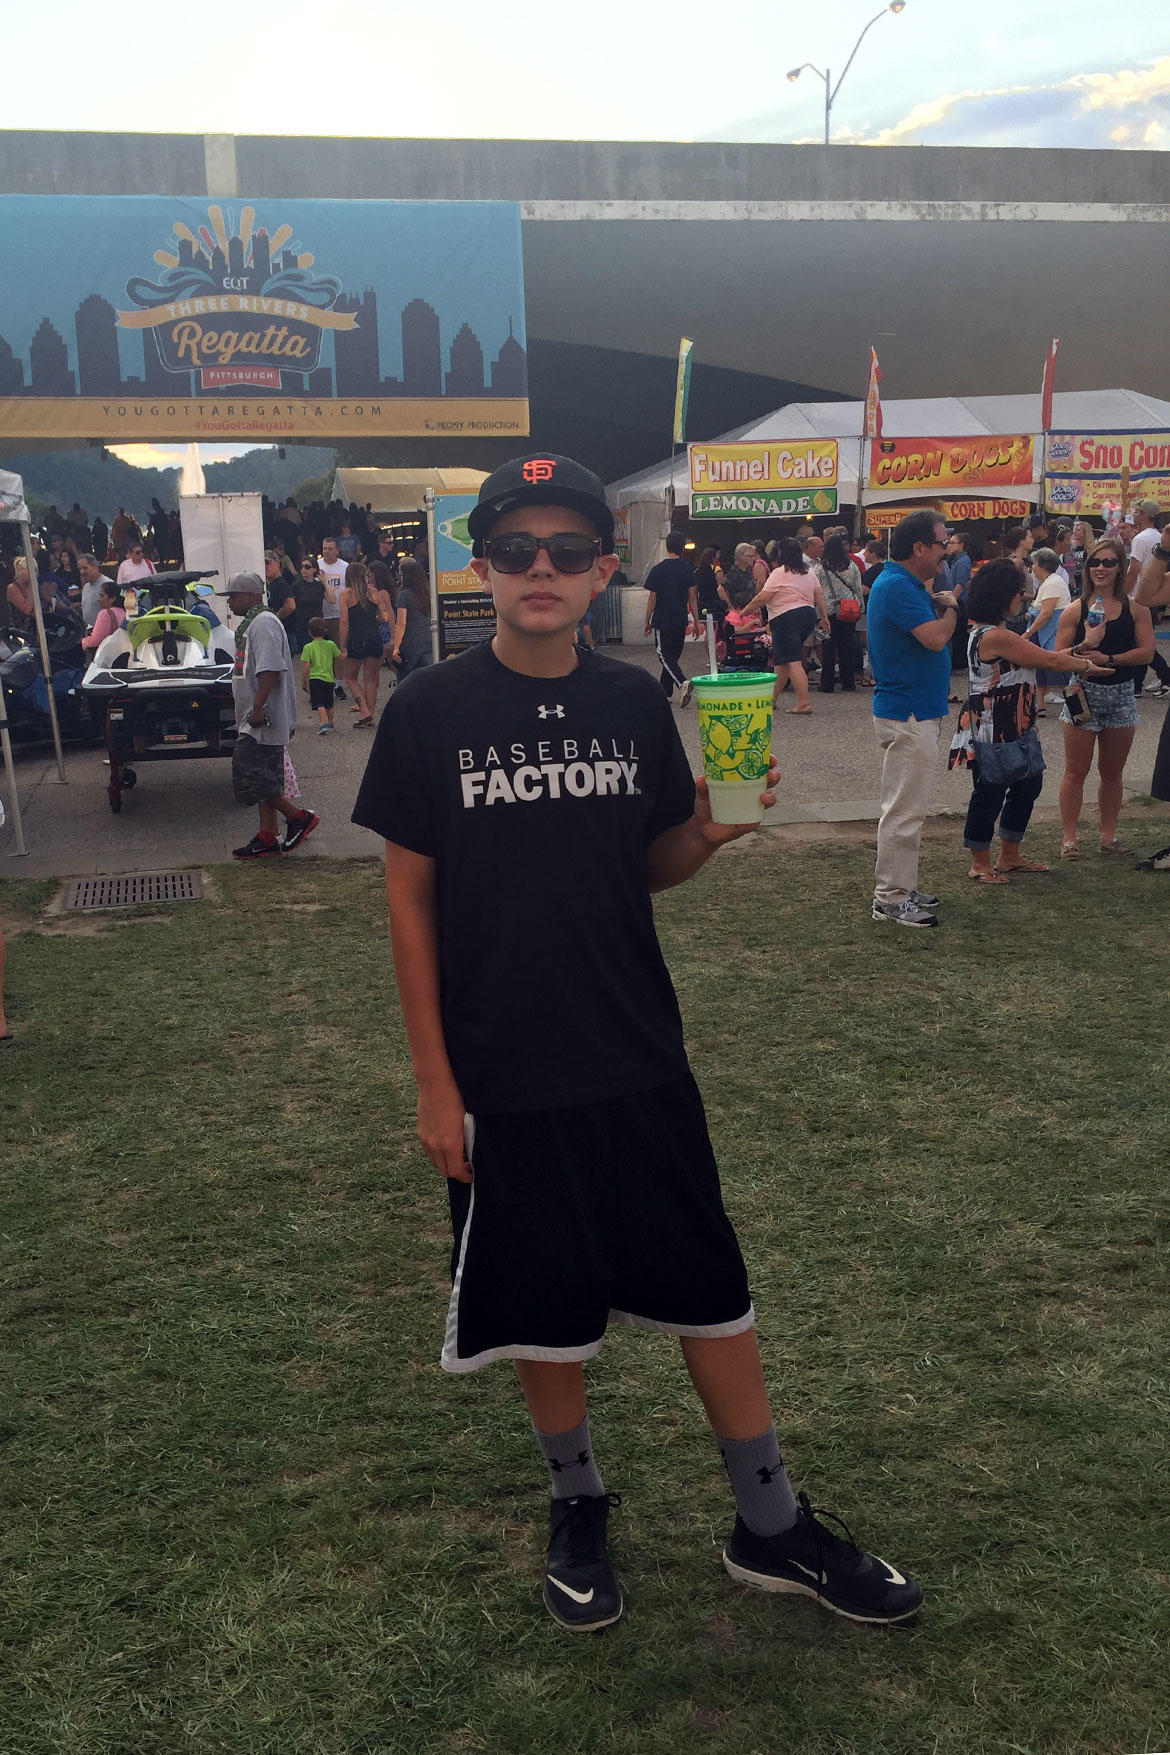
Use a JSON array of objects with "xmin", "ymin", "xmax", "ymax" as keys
[{"xmin": 353, "ymin": 644, "xmax": 695, "ymax": 1113}]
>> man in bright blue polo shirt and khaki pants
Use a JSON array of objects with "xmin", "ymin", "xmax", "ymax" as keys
[{"xmin": 867, "ymin": 511, "xmax": 956, "ymax": 927}]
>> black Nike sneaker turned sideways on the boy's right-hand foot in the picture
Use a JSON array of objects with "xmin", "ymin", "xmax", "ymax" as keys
[{"xmin": 723, "ymin": 1494, "xmax": 923, "ymax": 1625}]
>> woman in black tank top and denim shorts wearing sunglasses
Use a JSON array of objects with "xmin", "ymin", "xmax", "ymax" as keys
[{"xmin": 1056, "ymin": 537, "xmax": 1154, "ymax": 860}]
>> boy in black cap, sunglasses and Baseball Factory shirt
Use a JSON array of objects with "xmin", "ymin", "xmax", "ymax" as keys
[{"xmin": 354, "ymin": 455, "xmax": 921, "ymax": 1632}]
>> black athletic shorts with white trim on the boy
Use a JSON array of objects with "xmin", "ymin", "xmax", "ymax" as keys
[{"xmin": 442, "ymin": 1072, "xmax": 756, "ymax": 1371}]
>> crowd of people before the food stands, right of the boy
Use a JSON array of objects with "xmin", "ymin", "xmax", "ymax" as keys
[{"xmin": 634, "ymin": 500, "xmax": 1170, "ymax": 927}]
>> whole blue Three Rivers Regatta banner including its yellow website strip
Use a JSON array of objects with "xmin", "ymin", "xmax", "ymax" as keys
[{"xmin": 0, "ymin": 195, "xmax": 528, "ymax": 438}]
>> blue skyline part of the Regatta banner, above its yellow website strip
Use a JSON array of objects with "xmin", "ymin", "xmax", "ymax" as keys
[{"xmin": 0, "ymin": 197, "xmax": 528, "ymax": 402}]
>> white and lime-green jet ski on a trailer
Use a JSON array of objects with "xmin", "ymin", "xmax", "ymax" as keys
[{"xmin": 81, "ymin": 572, "xmax": 235, "ymax": 811}]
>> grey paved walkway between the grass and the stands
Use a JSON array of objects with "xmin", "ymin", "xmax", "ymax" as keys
[{"xmin": 0, "ymin": 644, "xmax": 1166, "ymax": 878}]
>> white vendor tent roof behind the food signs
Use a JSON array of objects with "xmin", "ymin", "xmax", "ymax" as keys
[{"xmin": 607, "ymin": 390, "xmax": 1170, "ymax": 579}]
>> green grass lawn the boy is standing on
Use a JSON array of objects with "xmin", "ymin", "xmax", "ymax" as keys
[{"xmin": 0, "ymin": 823, "xmax": 1170, "ymax": 1755}]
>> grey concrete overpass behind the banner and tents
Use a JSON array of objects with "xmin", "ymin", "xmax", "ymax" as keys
[{"xmin": 0, "ymin": 132, "xmax": 1170, "ymax": 479}]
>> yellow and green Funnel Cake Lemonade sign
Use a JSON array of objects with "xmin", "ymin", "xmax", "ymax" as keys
[{"xmin": 686, "ymin": 439, "xmax": 837, "ymax": 518}]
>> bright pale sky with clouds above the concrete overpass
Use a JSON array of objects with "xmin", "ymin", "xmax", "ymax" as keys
[{"xmin": 27, "ymin": 0, "xmax": 1170, "ymax": 467}]
